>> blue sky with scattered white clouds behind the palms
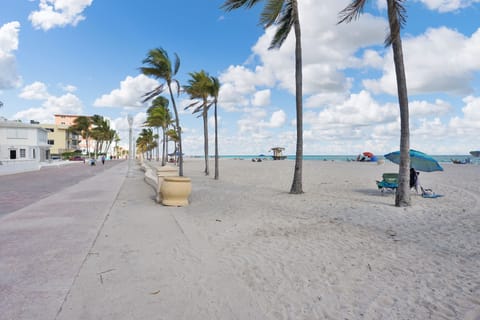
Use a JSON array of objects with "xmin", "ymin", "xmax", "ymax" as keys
[{"xmin": 0, "ymin": 0, "xmax": 480, "ymax": 155}]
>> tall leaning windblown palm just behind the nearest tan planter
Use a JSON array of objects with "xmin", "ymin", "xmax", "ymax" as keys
[{"xmin": 140, "ymin": 48, "xmax": 183, "ymax": 176}]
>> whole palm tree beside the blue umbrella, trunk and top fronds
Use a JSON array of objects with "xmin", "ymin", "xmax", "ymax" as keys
[{"xmin": 339, "ymin": 0, "xmax": 411, "ymax": 207}]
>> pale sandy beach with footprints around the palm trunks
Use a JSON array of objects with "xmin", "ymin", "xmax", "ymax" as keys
[{"xmin": 53, "ymin": 159, "xmax": 480, "ymax": 320}]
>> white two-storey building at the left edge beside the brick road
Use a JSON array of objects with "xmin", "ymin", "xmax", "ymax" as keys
[{"xmin": 0, "ymin": 117, "xmax": 50, "ymax": 171}]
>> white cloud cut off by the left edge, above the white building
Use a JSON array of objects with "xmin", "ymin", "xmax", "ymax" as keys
[{"xmin": 0, "ymin": 21, "xmax": 20, "ymax": 90}]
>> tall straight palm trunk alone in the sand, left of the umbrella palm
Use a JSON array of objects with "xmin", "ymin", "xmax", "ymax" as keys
[{"xmin": 290, "ymin": 0, "xmax": 303, "ymax": 194}]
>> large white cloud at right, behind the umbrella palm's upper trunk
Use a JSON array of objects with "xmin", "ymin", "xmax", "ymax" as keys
[{"xmin": 363, "ymin": 27, "xmax": 480, "ymax": 95}]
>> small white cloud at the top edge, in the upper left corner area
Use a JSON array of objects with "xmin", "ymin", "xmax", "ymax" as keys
[{"xmin": 28, "ymin": 0, "xmax": 93, "ymax": 31}]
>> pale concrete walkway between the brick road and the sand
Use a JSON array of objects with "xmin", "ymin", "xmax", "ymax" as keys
[{"xmin": 0, "ymin": 161, "xmax": 152, "ymax": 320}]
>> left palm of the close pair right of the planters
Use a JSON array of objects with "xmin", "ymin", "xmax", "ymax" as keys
[{"xmin": 183, "ymin": 70, "xmax": 212, "ymax": 176}]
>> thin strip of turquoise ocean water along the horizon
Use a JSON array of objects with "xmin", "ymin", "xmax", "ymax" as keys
[{"xmin": 220, "ymin": 154, "xmax": 480, "ymax": 164}]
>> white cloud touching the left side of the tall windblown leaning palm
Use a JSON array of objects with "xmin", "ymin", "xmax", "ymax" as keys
[{"xmin": 93, "ymin": 74, "xmax": 159, "ymax": 108}]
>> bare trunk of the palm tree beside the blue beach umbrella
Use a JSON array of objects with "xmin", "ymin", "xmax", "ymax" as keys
[{"xmin": 387, "ymin": 0, "xmax": 411, "ymax": 207}]
